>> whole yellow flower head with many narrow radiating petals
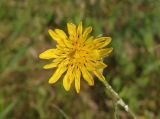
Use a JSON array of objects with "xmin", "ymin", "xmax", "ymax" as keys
[{"xmin": 39, "ymin": 22, "xmax": 112, "ymax": 93}]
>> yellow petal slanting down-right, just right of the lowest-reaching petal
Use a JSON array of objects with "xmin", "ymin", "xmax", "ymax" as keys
[{"xmin": 80, "ymin": 66, "xmax": 94, "ymax": 86}]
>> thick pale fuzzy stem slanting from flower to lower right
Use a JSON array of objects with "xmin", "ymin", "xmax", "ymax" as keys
[{"xmin": 101, "ymin": 80, "xmax": 137, "ymax": 119}]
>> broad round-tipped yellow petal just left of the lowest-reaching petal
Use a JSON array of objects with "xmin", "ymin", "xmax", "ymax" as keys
[{"xmin": 63, "ymin": 67, "xmax": 74, "ymax": 91}]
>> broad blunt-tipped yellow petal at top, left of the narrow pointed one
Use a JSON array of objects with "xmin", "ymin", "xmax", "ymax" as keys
[{"xmin": 67, "ymin": 23, "xmax": 76, "ymax": 36}]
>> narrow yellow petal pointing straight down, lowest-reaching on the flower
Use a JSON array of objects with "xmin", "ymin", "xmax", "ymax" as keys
[{"xmin": 74, "ymin": 68, "xmax": 81, "ymax": 93}]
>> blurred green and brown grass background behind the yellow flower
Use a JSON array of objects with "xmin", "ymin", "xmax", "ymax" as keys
[{"xmin": 0, "ymin": 0, "xmax": 160, "ymax": 119}]
